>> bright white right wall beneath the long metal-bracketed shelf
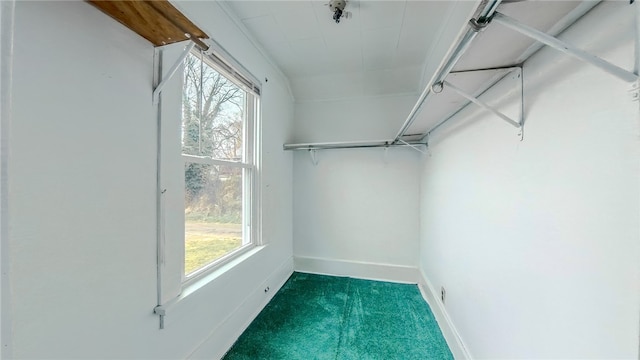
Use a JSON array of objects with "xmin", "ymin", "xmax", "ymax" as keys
[{"xmin": 420, "ymin": 2, "xmax": 640, "ymax": 358}]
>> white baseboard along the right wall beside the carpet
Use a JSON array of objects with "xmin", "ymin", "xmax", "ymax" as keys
[{"xmin": 418, "ymin": 271, "xmax": 473, "ymax": 360}]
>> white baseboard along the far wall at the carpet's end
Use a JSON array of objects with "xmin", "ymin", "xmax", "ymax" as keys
[{"xmin": 293, "ymin": 256, "xmax": 420, "ymax": 284}]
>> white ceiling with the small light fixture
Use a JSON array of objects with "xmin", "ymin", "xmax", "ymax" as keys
[{"xmin": 227, "ymin": 0, "xmax": 454, "ymax": 100}]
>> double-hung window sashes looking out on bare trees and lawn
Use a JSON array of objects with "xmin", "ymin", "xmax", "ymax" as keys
[{"xmin": 181, "ymin": 52, "xmax": 259, "ymax": 280}]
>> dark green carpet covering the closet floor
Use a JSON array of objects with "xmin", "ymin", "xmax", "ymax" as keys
[{"xmin": 224, "ymin": 273, "xmax": 453, "ymax": 360}]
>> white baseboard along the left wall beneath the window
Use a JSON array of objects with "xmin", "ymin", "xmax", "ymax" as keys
[{"xmin": 188, "ymin": 258, "xmax": 293, "ymax": 359}]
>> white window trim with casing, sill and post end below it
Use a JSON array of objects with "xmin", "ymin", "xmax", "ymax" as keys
[{"xmin": 152, "ymin": 43, "xmax": 266, "ymax": 329}]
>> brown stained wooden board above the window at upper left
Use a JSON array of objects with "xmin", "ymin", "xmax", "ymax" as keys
[{"xmin": 87, "ymin": 0, "xmax": 209, "ymax": 47}]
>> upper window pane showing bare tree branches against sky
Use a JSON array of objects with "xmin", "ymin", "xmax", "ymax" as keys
[{"xmin": 182, "ymin": 55, "xmax": 247, "ymax": 161}]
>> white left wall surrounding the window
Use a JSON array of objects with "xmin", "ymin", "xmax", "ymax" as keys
[{"xmin": 3, "ymin": 2, "xmax": 293, "ymax": 358}]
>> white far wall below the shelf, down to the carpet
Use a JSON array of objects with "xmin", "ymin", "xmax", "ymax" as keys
[{"xmin": 293, "ymin": 148, "xmax": 420, "ymax": 282}]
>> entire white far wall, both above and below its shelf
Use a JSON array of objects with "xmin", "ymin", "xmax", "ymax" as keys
[{"xmin": 293, "ymin": 95, "xmax": 420, "ymax": 281}]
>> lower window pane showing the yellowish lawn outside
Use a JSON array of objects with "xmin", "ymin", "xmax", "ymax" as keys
[{"xmin": 184, "ymin": 163, "xmax": 248, "ymax": 275}]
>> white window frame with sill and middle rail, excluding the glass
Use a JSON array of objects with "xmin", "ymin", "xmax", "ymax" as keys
[{"xmin": 154, "ymin": 42, "xmax": 263, "ymax": 307}]
